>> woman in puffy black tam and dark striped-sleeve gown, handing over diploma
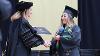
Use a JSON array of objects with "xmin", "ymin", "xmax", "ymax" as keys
[{"xmin": 6, "ymin": 1, "xmax": 44, "ymax": 56}]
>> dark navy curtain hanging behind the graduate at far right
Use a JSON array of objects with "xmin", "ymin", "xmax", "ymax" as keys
[{"xmin": 78, "ymin": 0, "xmax": 100, "ymax": 49}]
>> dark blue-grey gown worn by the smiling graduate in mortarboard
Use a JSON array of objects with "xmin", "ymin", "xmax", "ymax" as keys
[{"xmin": 50, "ymin": 25, "xmax": 81, "ymax": 56}]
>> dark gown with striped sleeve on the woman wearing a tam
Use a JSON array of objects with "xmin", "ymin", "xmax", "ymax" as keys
[{"xmin": 6, "ymin": 17, "xmax": 44, "ymax": 56}]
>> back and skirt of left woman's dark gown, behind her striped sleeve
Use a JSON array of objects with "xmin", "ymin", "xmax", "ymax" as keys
[{"xmin": 6, "ymin": 19, "xmax": 31, "ymax": 56}]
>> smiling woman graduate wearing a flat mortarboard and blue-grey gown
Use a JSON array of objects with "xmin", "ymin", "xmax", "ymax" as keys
[{"xmin": 50, "ymin": 6, "xmax": 81, "ymax": 56}]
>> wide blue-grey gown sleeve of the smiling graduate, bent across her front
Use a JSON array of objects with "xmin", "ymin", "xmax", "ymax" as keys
[{"xmin": 60, "ymin": 26, "xmax": 81, "ymax": 46}]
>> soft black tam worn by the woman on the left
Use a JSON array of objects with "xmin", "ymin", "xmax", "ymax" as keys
[{"xmin": 16, "ymin": 1, "xmax": 33, "ymax": 12}]
